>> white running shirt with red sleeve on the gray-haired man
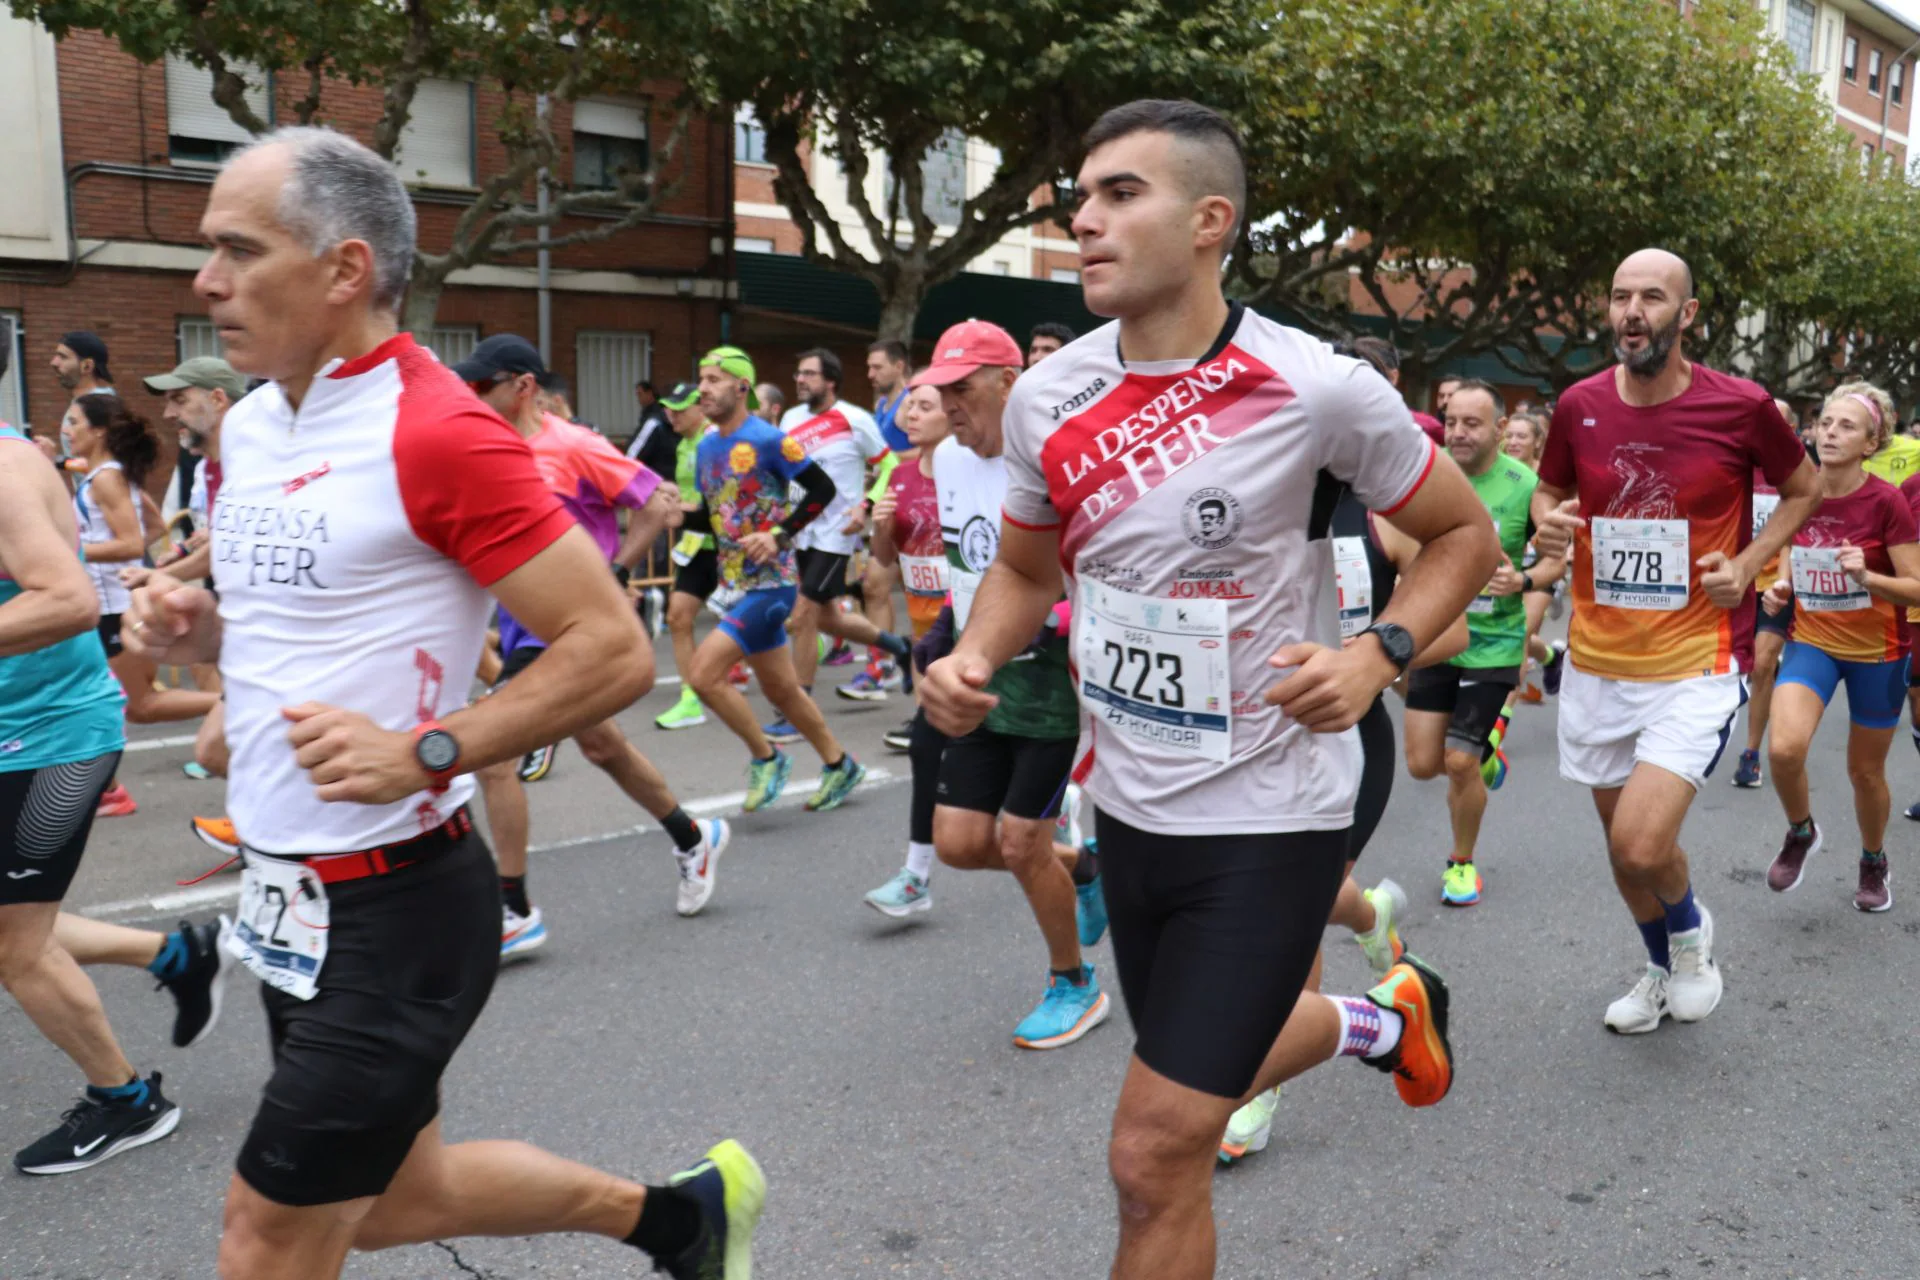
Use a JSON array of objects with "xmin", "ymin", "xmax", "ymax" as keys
[{"xmin": 213, "ymin": 334, "xmax": 574, "ymax": 856}]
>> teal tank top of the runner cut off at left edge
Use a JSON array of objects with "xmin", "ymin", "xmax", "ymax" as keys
[{"xmin": 0, "ymin": 426, "xmax": 127, "ymax": 773}]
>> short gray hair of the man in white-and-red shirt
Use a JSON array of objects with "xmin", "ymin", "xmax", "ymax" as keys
[{"xmin": 227, "ymin": 125, "xmax": 419, "ymax": 311}]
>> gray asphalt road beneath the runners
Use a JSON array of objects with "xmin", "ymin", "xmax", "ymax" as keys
[{"xmin": 0, "ymin": 625, "xmax": 1920, "ymax": 1280}]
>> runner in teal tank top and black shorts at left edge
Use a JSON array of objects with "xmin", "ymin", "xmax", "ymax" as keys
[{"xmin": 0, "ymin": 426, "xmax": 223, "ymax": 1173}]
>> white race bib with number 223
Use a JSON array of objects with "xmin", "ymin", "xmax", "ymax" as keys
[{"xmin": 1073, "ymin": 581, "xmax": 1233, "ymax": 764}]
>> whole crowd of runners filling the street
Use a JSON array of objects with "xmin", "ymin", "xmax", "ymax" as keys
[{"xmin": 0, "ymin": 100, "xmax": 1920, "ymax": 1280}]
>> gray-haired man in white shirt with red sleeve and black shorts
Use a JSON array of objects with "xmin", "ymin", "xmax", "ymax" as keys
[{"xmin": 125, "ymin": 129, "xmax": 766, "ymax": 1280}]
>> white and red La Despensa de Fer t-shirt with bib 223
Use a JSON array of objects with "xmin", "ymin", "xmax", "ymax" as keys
[{"xmin": 1004, "ymin": 303, "xmax": 1436, "ymax": 835}]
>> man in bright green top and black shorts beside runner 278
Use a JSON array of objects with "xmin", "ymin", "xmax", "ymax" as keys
[{"xmin": 1407, "ymin": 378, "xmax": 1561, "ymax": 906}]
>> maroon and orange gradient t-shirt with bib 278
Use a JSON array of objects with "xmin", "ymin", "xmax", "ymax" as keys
[{"xmin": 1540, "ymin": 365, "xmax": 1807, "ymax": 679}]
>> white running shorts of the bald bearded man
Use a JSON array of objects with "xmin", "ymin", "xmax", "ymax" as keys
[{"xmin": 1559, "ymin": 662, "xmax": 1747, "ymax": 791}]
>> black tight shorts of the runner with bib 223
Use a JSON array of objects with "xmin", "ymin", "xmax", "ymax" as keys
[{"xmin": 1094, "ymin": 810, "xmax": 1348, "ymax": 1098}]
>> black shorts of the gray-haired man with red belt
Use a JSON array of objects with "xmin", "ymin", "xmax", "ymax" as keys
[{"xmin": 238, "ymin": 833, "xmax": 499, "ymax": 1207}]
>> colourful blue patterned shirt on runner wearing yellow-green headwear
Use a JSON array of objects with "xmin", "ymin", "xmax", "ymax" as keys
[{"xmin": 693, "ymin": 416, "xmax": 808, "ymax": 591}]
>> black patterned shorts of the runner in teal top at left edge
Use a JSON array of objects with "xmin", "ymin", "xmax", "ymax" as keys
[{"xmin": 0, "ymin": 750, "xmax": 121, "ymax": 906}]
